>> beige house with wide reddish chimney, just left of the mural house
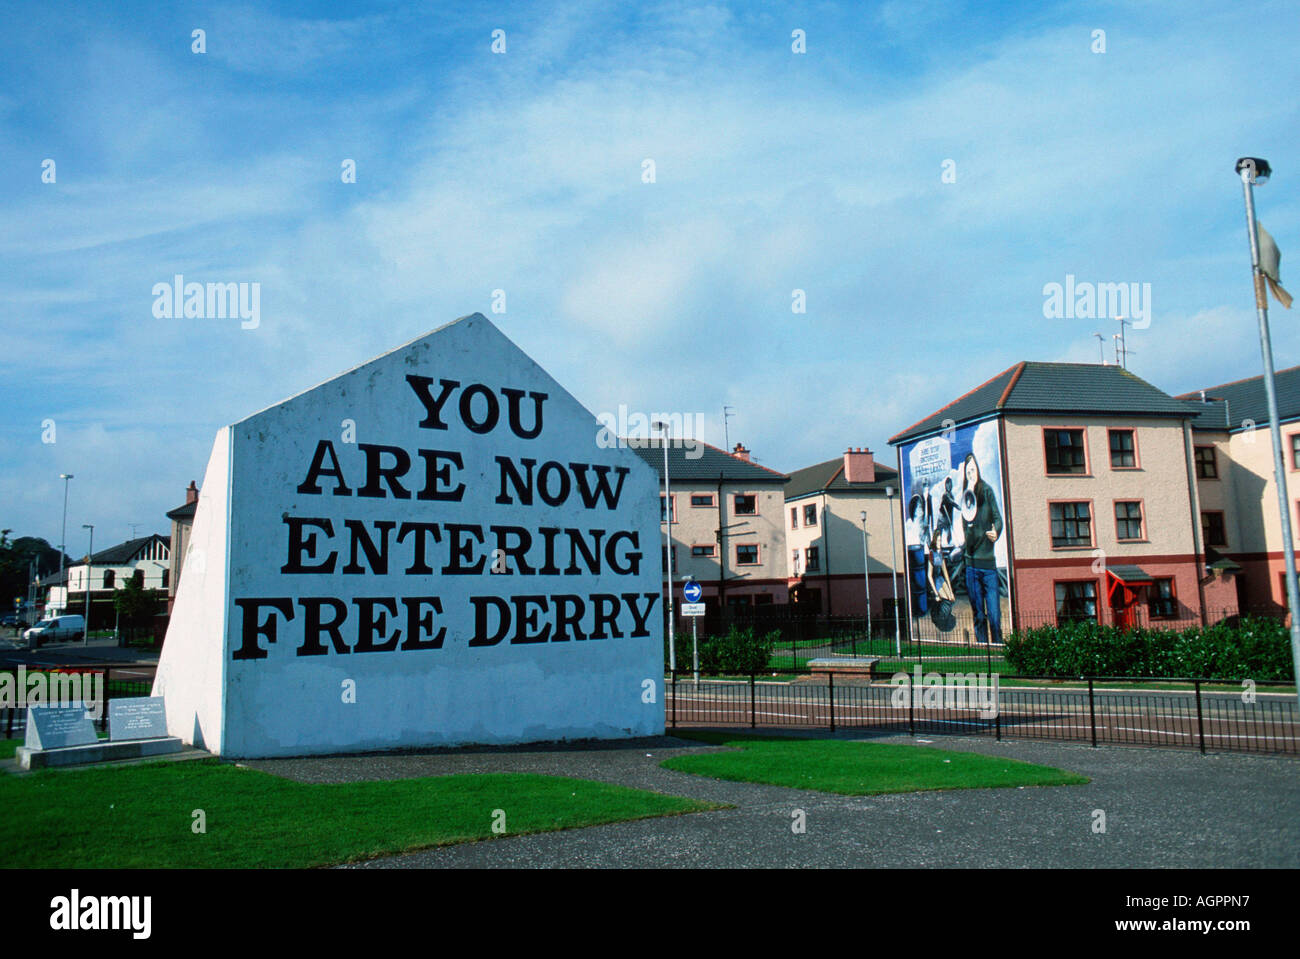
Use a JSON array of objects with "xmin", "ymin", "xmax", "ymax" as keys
[{"xmin": 785, "ymin": 448, "xmax": 907, "ymax": 619}]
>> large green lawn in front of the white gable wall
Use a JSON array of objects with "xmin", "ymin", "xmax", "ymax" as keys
[{"xmin": 0, "ymin": 746, "xmax": 722, "ymax": 869}]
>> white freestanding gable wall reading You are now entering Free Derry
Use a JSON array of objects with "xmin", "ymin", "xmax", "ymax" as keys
[{"xmin": 155, "ymin": 314, "xmax": 663, "ymax": 756}]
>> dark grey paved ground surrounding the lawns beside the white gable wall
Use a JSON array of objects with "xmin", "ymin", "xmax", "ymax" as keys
[{"xmin": 239, "ymin": 732, "xmax": 1300, "ymax": 868}]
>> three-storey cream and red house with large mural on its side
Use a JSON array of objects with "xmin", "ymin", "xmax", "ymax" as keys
[{"xmin": 889, "ymin": 363, "xmax": 1236, "ymax": 628}]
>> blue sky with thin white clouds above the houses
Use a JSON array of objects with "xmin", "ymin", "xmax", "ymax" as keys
[{"xmin": 0, "ymin": 1, "xmax": 1300, "ymax": 554}]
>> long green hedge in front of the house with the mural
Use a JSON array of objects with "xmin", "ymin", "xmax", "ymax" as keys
[{"xmin": 1006, "ymin": 617, "xmax": 1292, "ymax": 681}]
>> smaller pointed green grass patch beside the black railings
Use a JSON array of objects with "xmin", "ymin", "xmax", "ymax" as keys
[{"xmin": 660, "ymin": 732, "xmax": 1088, "ymax": 795}]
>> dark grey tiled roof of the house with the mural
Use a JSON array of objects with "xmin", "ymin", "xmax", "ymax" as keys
[{"xmin": 889, "ymin": 361, "xmax": 1199, "ymax": 444}]
